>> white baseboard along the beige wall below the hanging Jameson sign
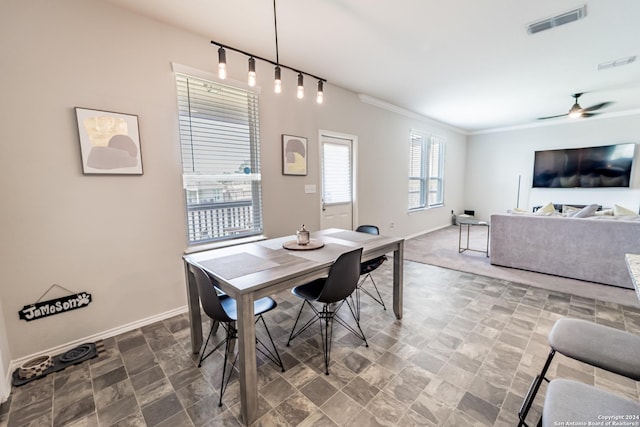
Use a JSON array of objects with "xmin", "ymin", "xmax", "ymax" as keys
[{"xmin": 0, "ymin": 305, "xmax": 188, "ymax": 402}]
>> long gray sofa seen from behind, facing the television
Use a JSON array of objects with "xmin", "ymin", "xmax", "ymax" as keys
[{"xmin": 491, "ymin": 214, "xmax": 640, "ymax": 289}]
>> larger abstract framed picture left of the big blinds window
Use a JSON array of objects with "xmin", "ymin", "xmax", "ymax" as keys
[{"xmin": 75, "ymin": 107, "xmax": 142, "ymax": 175}]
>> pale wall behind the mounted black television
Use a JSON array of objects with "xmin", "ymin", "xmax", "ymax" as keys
[{"xmin": 464, "ymin": 114, "xmax": 640, "ymax": 219}]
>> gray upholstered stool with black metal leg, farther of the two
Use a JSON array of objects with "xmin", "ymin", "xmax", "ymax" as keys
[{"xmin": 518, "ymin": 318, "xmax": 640, "ymax": 426}]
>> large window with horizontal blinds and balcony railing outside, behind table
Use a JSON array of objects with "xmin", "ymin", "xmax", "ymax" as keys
[{"xmin": 176, "ymin": 73, "xmax": 262, "ymax": 245}]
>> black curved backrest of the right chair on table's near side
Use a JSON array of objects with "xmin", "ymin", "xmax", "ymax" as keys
[{"xmin": 316, "ymin": 248, "xmax": 362, "ymax": 303}]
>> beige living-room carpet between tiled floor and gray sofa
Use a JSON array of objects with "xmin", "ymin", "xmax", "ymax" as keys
[{"xmin": 404, "ymin": 226, "xmax": 640, "ymax": 307}]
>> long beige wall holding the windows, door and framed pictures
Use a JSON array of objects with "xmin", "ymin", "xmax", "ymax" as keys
[{"xmin": 0, "ymin": 0, "xmax": 466, "ymax": 378}]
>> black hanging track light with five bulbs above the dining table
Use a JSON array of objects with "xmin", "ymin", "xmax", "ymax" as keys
[{"xmin": 211, "ymin": 0, "xmax": 326, "ymax": 104}]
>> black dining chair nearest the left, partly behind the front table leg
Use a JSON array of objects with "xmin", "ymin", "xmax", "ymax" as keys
[{"xmin": 189, "ymin": 264, "xmax": 284, "ymax": 406}]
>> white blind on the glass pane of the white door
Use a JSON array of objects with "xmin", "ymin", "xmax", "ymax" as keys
[{"xmin": 322, "ymin": 142, "xmax": 352, "ymax": 204}]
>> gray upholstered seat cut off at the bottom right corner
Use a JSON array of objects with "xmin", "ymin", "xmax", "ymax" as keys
[{"xmin": 542, "ymin": 379, "xmax": 640, "ymax": 427}]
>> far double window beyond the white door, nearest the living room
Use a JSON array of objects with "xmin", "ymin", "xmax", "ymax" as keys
[{"xmin": 409, "ymin": 131, "xmax": 444, "ymax": 210}]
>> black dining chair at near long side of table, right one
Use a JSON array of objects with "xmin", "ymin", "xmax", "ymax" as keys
[{"xmin": 287, "ymin": 248, "xmax": 369, "ymax": 375}]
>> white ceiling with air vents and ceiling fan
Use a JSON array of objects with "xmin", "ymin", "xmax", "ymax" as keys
[{"xmin": 105, "ymin": 0, "xmax": 640, "ymax": 133}]
